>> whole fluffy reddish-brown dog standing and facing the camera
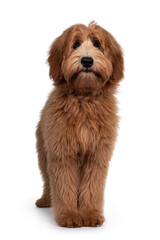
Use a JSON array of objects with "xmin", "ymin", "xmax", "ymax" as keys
[{"xmin": 36, "ymin": 22, "xmax": 124, "ymax": 228}]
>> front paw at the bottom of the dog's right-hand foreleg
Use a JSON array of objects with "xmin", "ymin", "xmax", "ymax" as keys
[{"xmin": 80, "ymin": 210, "xmax": 105, "ymax": 227}]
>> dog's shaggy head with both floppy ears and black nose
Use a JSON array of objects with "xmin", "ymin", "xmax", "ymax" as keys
[{"xmin": 48, "ymin": 22, "xmax": 124, "ymax": 92}]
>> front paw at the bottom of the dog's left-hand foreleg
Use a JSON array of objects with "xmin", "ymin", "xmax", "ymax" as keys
[{"xmin": 57, "ymin": 212, "xmax": 82, "ymax": 228}]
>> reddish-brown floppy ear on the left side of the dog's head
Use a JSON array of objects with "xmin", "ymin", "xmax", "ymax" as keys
[{"xmin": 47, "ymin": 27, "xmax": 73, "ymax": 82}]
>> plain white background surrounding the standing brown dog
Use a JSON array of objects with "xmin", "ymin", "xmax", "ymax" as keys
[{"xmin": 0, "ymin": 0, "xmax": 160, "ymax": 240}]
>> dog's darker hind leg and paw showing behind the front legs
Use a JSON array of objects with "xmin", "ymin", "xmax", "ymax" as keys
[{"xmin": 35, "ymin": 123, "xmax": 51, "ymax": 207}]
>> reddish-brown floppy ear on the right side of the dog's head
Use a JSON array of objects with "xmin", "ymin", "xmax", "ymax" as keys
[{"xmin": 103, "ymin": 29, "xmax": 124, "ymax": 83}]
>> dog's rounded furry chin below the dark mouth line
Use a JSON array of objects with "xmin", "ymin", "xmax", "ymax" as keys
[{"xmin": 70, "ymin": 70, "xmax": 103, "ymax": 92}]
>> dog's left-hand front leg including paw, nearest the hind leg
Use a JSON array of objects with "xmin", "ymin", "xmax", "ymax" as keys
[{"xmin": 48, "ymin": 153, "xmax": 82, "ymax": 227}]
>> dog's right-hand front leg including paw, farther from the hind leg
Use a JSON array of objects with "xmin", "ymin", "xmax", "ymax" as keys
[{"xmin": 79, "ymin": 145, "xmax": 111, "ymax": 227}]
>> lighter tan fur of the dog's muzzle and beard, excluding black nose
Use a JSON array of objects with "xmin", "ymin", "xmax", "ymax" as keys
[{"xmin": 62, "ymin": 38, "xmax": 112, "ymax": 92}]
